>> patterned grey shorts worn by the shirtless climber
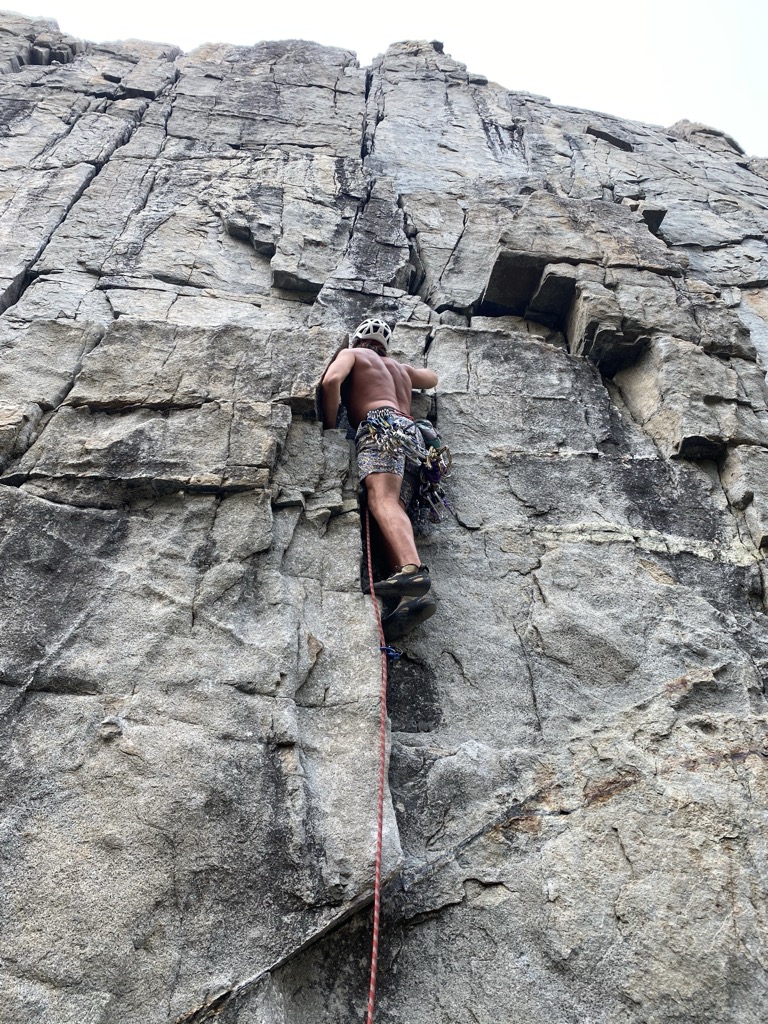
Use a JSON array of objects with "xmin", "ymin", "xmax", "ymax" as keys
[{"xmin": 354, "ymin": 406, "xmax": 427, "ymax": 508}]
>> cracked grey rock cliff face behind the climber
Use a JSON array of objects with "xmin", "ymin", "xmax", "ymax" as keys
[{"xmin": 0, "ymin": 15, "xmax": 768, "ymax": 1024}]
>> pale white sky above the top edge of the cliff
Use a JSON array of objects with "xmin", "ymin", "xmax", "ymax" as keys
[{"xmin": 9, "ymin": 0, "xmax": 768, "ymax": 157}]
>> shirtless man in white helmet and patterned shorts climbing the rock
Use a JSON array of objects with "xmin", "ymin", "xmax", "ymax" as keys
[{"xmin": 321, "ymin": 317, "xmax": 437, "ymax": 639}]
